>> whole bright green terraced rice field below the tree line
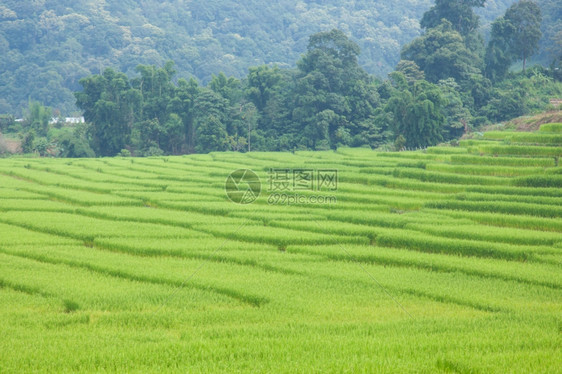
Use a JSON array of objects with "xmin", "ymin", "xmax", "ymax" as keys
[{"xmin": 0, "ymin": 124, "xmax": 562, "ymax": 373}]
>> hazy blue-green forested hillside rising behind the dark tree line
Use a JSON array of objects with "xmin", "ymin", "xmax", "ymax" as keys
[{"xmin": 0, "ymin": 0, "xmax": 520, "ymax": 116}]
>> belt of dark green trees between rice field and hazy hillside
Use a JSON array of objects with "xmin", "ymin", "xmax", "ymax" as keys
[{"xmin": 0, "ymin": 0, "xmax": 562, "ymax": 157}]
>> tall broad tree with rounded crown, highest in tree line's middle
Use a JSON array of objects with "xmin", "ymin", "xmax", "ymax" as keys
[{"xmin": 293, "ymin": 29, "xmax": 379, "ymax": 149}]
